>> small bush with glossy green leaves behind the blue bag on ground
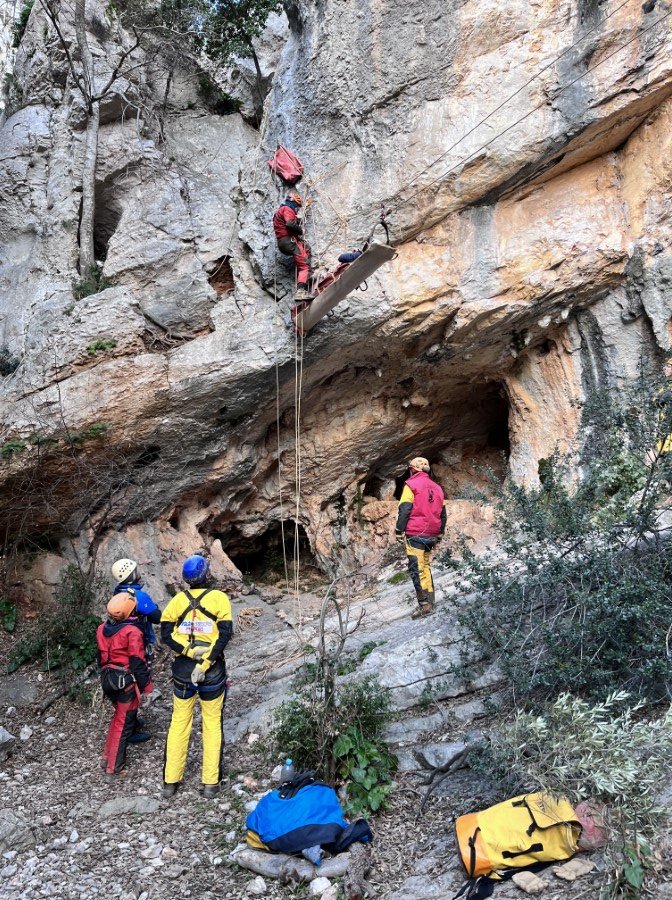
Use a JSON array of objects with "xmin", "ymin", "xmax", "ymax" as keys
[{"xmin": 270, "ymin": 666, "xmax": 396, "ymax": 815}]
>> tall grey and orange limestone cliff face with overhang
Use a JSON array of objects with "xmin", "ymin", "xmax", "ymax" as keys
[{"xmin": 0, "ymin": 0, "xmax": 672, "ymax": 596}]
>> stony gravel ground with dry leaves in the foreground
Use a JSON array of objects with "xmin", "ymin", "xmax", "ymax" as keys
[{"xmin": 0, "ymin": 616, "xmax": 616, "ymax": 900}]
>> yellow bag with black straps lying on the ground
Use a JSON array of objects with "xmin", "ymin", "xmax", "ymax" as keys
[{"xmin": 455, "ymin": 793, "xmax": 581, "ymax": 878}]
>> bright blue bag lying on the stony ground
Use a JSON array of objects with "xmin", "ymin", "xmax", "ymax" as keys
[{"xmin": 246, "ymin": 784, "xmax": 373, "ymax": 853}]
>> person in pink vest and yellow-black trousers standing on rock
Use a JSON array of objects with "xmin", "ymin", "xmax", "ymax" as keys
[{"xmin": 395, "ymin": 456, "xmax": 446, "ymax": 619}]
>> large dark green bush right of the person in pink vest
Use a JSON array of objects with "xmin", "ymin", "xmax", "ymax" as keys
[{"xmin": 444, "ymin": 370, "xmax": 672, "ymax": 704}]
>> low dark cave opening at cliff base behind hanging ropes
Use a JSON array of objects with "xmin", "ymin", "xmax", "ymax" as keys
[{"xmin": 219, "ymin": 519, "xmax": 320, "ymax": 584}]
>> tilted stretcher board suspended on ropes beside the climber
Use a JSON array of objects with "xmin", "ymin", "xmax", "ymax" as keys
[{"xmin": 292, "ymin": 241, "xmax": 396, "ymax": 334}]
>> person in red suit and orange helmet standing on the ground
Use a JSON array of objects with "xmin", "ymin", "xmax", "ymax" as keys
[{"xmin": 96, "ymin": 592, "xmax": 154, "ymax": 780}]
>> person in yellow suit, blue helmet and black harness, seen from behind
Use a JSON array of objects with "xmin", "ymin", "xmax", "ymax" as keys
[{"xmin": 161, "ymin": 556, "xmax": 233, "ymax": 799}]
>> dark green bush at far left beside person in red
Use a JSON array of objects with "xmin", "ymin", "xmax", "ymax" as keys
[{"xmin": 7, "ymin": 566, "xmax": 103, "ymax": 676}]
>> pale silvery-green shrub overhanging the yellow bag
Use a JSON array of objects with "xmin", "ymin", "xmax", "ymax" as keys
[{"xmin": 479, "ymin": 692, "xmax": 672, "ymax": 898}]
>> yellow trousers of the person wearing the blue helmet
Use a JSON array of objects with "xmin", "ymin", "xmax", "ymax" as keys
[{"xmin": 163, "ymin": 692, "xmax": 225, "ymax": 784}]
